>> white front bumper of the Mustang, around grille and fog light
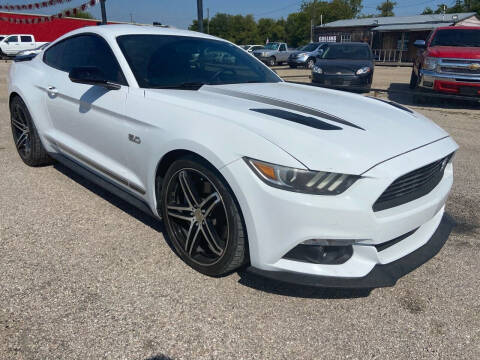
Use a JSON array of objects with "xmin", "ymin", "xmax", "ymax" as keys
[{"xmin": 221, "ymin": 138, "xmax": 458, "ymax": 286}]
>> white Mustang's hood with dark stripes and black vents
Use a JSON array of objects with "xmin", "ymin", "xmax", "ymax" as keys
[{"xmin": 146, "ymin": 82, "xmax": 448, "ymax": 175}]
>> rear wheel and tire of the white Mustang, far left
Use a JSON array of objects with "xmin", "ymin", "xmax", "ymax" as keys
[{"xmin": 10, "ymin": 96, "xmax": 52, "ymax": 167}]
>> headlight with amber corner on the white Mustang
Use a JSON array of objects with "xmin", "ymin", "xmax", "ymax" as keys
[{"xmin": 245, "ymin": 158, "xmax": 360, "ymax": 195}]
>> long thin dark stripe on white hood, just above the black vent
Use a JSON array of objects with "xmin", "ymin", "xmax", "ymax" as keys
[{"xmin": 202, "ymin": 87, "xmax": 365, "ymax": 131}]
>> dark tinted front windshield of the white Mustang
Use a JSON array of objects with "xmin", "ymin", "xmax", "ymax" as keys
[{"xmin": 117, "ymin": 35, "xmax": 282, "ymax": 88}]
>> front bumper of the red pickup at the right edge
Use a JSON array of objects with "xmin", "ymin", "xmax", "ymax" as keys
[{"xmin": 419, "ymin": 70, "xmax": 480, "ymax": 96}]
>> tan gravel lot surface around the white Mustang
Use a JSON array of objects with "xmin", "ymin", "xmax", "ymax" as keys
[{"xmin": 0, "ymin": 64, "xmax": 480, "ymax": 360}]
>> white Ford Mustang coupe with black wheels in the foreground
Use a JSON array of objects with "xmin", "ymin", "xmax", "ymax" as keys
[{"xmin": 9, "ymin": 25, "xmax": 458, "ymax": 287}]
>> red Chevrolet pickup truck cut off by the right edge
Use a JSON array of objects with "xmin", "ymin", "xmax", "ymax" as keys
[{"xmin": 410, "ymin": 26, "xmax": 480, "ymax": 96}]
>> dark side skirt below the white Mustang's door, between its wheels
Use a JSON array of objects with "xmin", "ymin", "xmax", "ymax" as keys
[{"xmin": 49, "ymin": 153, "xmax": 158, "ymax": 219}]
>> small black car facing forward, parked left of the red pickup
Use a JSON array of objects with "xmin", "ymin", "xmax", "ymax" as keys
[{"xmin": 312, "ymin": 42, "xmax": 375, "ymax": 92}]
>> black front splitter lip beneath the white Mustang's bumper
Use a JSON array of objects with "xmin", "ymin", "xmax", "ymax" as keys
[{"xmin": 247, "ymin": 215, "xmax": 453, "ymax": 289}]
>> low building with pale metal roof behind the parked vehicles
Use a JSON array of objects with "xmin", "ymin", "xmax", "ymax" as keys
[{"xmin": 315, "ymin": 12, "xmax": 480, "ymax": 63}]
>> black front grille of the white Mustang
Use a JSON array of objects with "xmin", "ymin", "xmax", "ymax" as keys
[{"xmin": 373, "ymin": 154, "xmax": 453, "ymax": 211}]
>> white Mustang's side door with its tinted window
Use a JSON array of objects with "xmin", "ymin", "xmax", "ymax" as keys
[{"xmin": 43, "ymin": 34, "xmax": 142, "ymax": 192}]
